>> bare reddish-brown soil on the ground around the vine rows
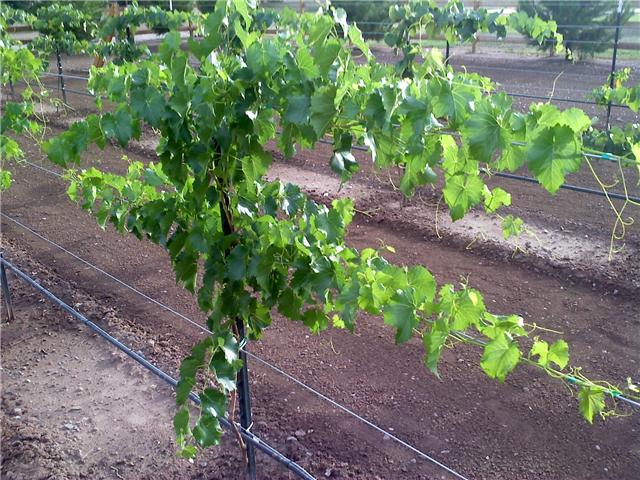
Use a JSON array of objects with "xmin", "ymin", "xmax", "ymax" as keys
[{"xmin": 2, "ymin": 47, "xmax": 640, "ymax": 480}]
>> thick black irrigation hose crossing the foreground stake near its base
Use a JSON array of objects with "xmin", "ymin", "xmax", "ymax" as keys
[{"xmin": 0, "ymin": 257, "xmax": 315, "ymax": 480}]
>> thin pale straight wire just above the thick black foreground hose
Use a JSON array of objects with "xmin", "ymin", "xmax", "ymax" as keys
[{"xmin": 0, "ymin": 212, "xmax": 468, "ymax": 480}]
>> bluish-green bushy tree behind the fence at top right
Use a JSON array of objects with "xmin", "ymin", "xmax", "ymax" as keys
[{"xmin": 518, "ymin": 0, "xmax": 635, "ymax": 58}]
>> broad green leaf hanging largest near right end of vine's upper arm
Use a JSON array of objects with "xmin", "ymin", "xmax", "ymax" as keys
[{"xmin": 527, "ymin": 126, "xmax": 582, "ymax": 193}]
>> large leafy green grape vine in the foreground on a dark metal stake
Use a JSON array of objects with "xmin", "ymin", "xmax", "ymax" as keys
[{"xmin": 2, "ymin": 0, "xmax": 638, "ymax": 464}]
